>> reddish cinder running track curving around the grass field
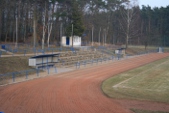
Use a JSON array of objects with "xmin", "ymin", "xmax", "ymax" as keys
[{"xmin": 0, "ymin": 53, "xmax": 169, "ymax": 113}]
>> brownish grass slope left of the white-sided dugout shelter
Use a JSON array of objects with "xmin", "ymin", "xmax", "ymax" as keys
[{"xmin": 0, "ymin": 56, "xmax": 32, "ymax": 74}]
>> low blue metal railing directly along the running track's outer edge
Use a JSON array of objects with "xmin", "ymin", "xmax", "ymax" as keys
[{"xmin": 0, "ymin": 53, "xmax": 125, "ymax": 85}]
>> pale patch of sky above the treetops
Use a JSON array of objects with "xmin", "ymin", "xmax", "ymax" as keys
[{"xmin": 139, "ymin": 0, "xmax": 169, "ymax": 8}]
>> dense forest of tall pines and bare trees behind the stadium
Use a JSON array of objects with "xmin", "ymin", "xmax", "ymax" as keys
[{"xmin": 0, "ymin": 0, "xmax": 169, "ymax": 48}]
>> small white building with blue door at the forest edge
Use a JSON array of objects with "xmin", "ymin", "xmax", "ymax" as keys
[{"xmin": 61, "ymin": 36, "xmax": 81, "ymax": 47}]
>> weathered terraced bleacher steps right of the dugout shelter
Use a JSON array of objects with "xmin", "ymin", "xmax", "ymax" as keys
[{"xmin": 55, "ymin": 50, "xmax": 108, "ymax": 67}]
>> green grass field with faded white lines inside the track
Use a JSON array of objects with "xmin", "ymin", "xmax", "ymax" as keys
[{"xmin": 102, "ymin": 58, "xmax": 169, "ymax": 103}]
